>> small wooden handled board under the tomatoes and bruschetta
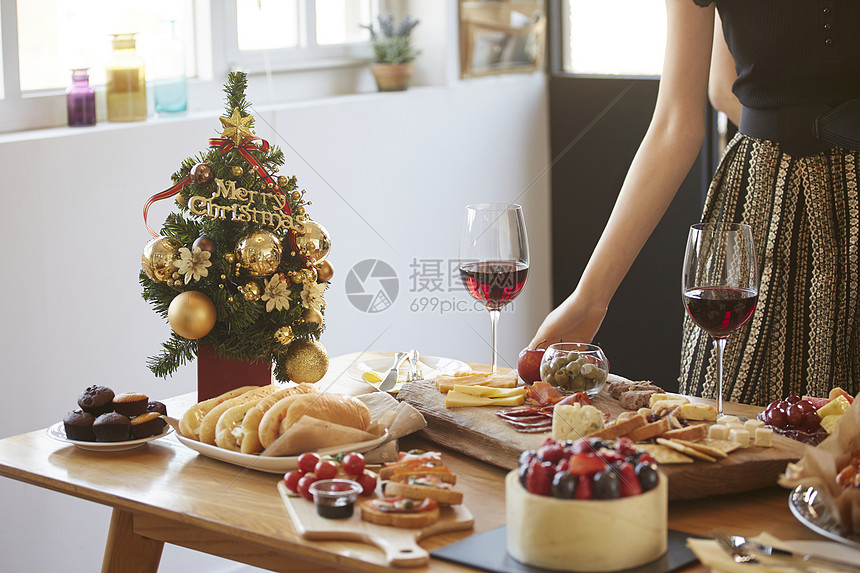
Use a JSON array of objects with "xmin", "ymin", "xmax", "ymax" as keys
[{"xmin": 278, "ymin": 481, "xmax": 475, "ymax": 567}]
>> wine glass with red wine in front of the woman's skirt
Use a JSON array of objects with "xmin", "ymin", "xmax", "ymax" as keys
[{"xmin": 681, "ymin": 223, "xmax": 758, "ymax": 414}]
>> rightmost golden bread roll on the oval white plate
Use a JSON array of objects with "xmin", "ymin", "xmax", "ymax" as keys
[{"xmin": 259, "ymin": 394, "xmax": 370, "ymax": 451}]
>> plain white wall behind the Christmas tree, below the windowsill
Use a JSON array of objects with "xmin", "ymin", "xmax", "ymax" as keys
[{"xmin": 0, "ymin": 75, "xmax": 550, "ymax": 572}]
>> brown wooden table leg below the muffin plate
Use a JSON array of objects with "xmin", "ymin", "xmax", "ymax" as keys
[{"xmin": 102, "ymin": 508, "xmax": 164, "ymax": 573}]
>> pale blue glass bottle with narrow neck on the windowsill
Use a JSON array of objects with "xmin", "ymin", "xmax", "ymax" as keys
[{"xmin": 152, "ymin": 20, "xmax": 188, "ymax": 113}]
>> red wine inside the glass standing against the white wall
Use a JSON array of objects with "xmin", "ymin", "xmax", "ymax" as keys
[{"xmin": 460, "ymin": 261, "xmax": 529, "ymax": 310}]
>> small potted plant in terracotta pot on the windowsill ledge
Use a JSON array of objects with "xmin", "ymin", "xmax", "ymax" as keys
[{"xmin": 363, "ymin": 13, "xmax": 421, "ymax": 92}]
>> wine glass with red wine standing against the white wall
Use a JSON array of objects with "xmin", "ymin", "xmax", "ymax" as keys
[{"xmin": 460, "ymin": 203, "xmax": 529, "ymax": 373}]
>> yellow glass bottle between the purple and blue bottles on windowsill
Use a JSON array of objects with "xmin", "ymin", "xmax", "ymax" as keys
[{"xmin": 105, "ymin": 34, "xmax": 146, "ymax": 121}]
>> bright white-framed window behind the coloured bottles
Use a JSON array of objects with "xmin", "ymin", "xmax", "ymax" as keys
[{"xmin": 0, "ymin": 0, "xmax": 382, "ymax": 133}]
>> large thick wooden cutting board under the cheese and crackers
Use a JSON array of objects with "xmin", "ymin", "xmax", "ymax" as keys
[{"xmin": 397, "ymin": 374, "xmax": 806, "ymax": 499}]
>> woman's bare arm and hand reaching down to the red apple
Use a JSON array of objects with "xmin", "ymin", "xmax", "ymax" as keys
[{"xmin": 529, "ymin": 0, "xmax": 714, "ymax": 347}]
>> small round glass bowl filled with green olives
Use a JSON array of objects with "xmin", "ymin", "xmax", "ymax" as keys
[{"xmin": 540, "ymin": 342, "xmax": 609, "ymax": 396}]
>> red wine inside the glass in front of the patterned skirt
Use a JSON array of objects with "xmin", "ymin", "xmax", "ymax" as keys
[{"xmin": 684, "ymin": 287, "xmax": 758, "ymax": 338}]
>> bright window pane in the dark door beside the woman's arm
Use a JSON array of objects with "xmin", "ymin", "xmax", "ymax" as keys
[{"xmin": 562, "ymin": 0, "xmax": 666, "ymax": 76}]
